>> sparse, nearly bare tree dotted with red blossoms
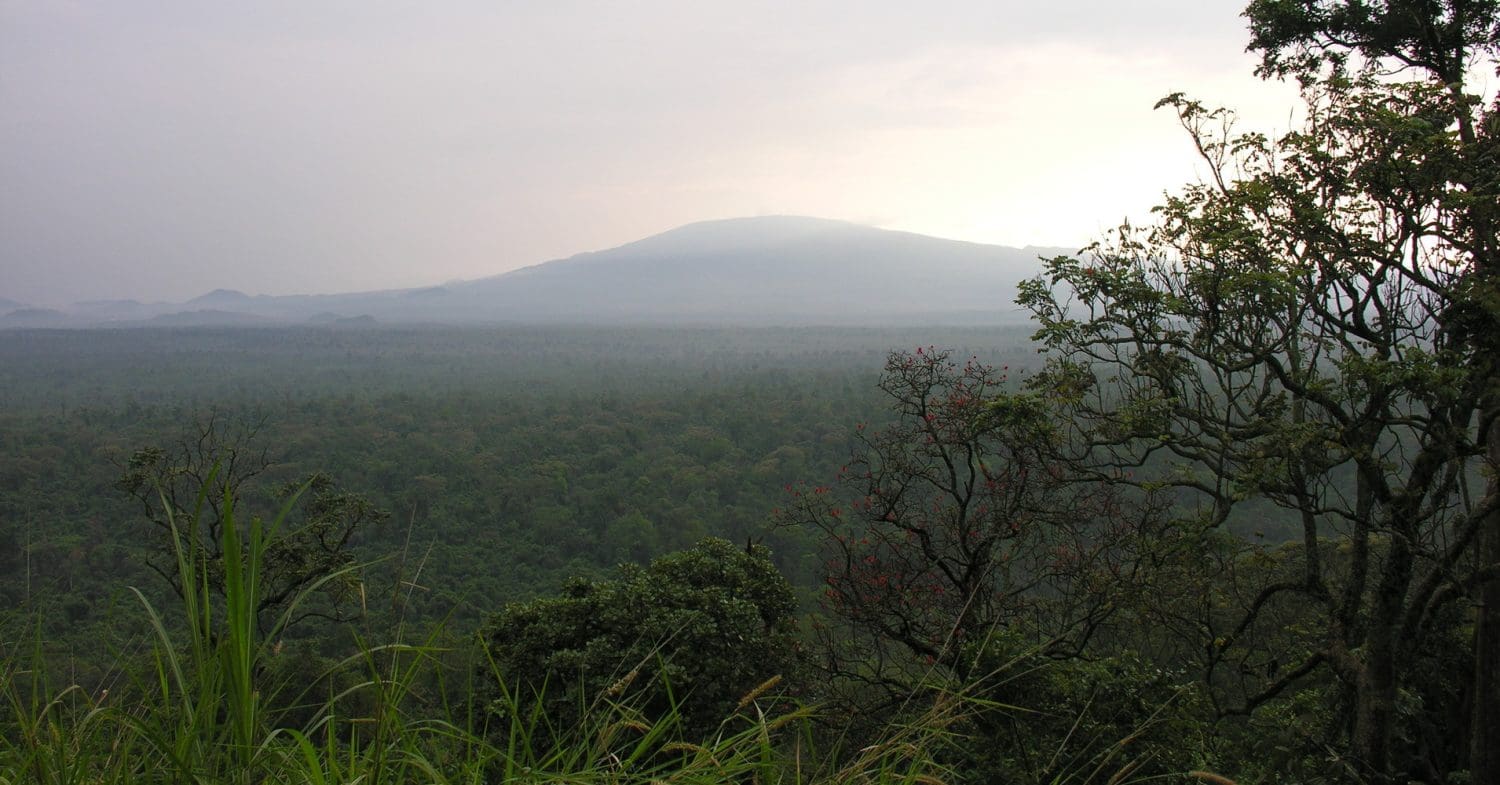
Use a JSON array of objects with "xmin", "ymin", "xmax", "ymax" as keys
[{"xmin": 777, "ymin": 348, "xmax": 1154, "ymax": 699}]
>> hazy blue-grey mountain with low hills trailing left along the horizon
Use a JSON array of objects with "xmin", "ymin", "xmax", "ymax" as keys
[{"xmin": 5, "ymin": 216, "xmax": 1067, "ymax": 326}]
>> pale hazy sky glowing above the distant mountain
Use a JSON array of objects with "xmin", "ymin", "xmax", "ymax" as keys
[{"xmin": 0, "ymin": 0, "xmax": 1293, "ymax": 303}]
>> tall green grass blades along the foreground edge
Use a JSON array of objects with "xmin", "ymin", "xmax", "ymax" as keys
[{"xmin": 0, "ymin": 474, "xmax": 963, "ymax": 785}]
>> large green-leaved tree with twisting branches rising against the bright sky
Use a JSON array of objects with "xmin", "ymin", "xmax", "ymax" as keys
[{"xmin": 1022, "ymin": 0, "xmax": 1500, "ymax": 782}]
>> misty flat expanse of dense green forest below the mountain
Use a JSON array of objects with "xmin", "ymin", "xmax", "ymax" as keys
[{"xmin": 0, "ymin": 327, "xmax": 1031, "ymax": 645}]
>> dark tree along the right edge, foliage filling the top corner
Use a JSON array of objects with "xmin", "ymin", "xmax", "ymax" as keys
[{"xmin": 1247, "ymin": 0, "xmax": 1500, "ymax": 782}]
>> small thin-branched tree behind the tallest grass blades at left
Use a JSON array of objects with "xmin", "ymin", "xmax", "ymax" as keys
[{"xmin": 117, "ymin": 413, "xmax": 386, "ymax": 632}]
